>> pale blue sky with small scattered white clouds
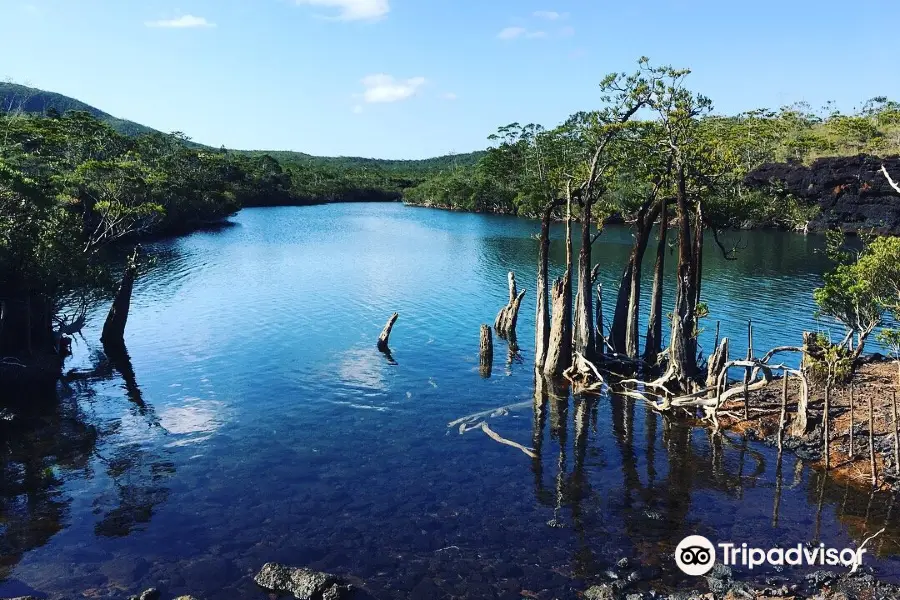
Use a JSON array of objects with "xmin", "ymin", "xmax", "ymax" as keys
[{"xmin": 0, "ymin": 0, "xmax": 900, "ymax": 158}]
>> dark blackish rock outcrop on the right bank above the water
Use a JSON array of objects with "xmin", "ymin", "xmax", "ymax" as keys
[{"xmin": 744, "ymin": 154, "xmax": 900, "ymax": 235}]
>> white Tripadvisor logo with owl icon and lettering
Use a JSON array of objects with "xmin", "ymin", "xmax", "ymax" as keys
[{"xmin": 675, "ymin": 535, "xmax": 866, "ymax": 577}]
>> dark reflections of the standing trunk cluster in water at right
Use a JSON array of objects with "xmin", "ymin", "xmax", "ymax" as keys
[{"xmin": 531, "ymin": 374, "xmax": 900, "ymax": 579}]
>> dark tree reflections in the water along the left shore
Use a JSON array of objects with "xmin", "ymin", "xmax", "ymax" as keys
[{"xmin": 0, "ymin": 348, "xmax": 175, "ymax": 581}]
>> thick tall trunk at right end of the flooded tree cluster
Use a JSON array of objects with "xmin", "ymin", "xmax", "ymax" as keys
[{"xmin": 669, "ymin": 164, "xmax": 697, "ymax": 392}]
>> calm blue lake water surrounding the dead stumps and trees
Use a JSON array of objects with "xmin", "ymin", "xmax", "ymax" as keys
[{"xmin": 0, "ymin": 204, "xmax": 900, "ymax": 600}]
